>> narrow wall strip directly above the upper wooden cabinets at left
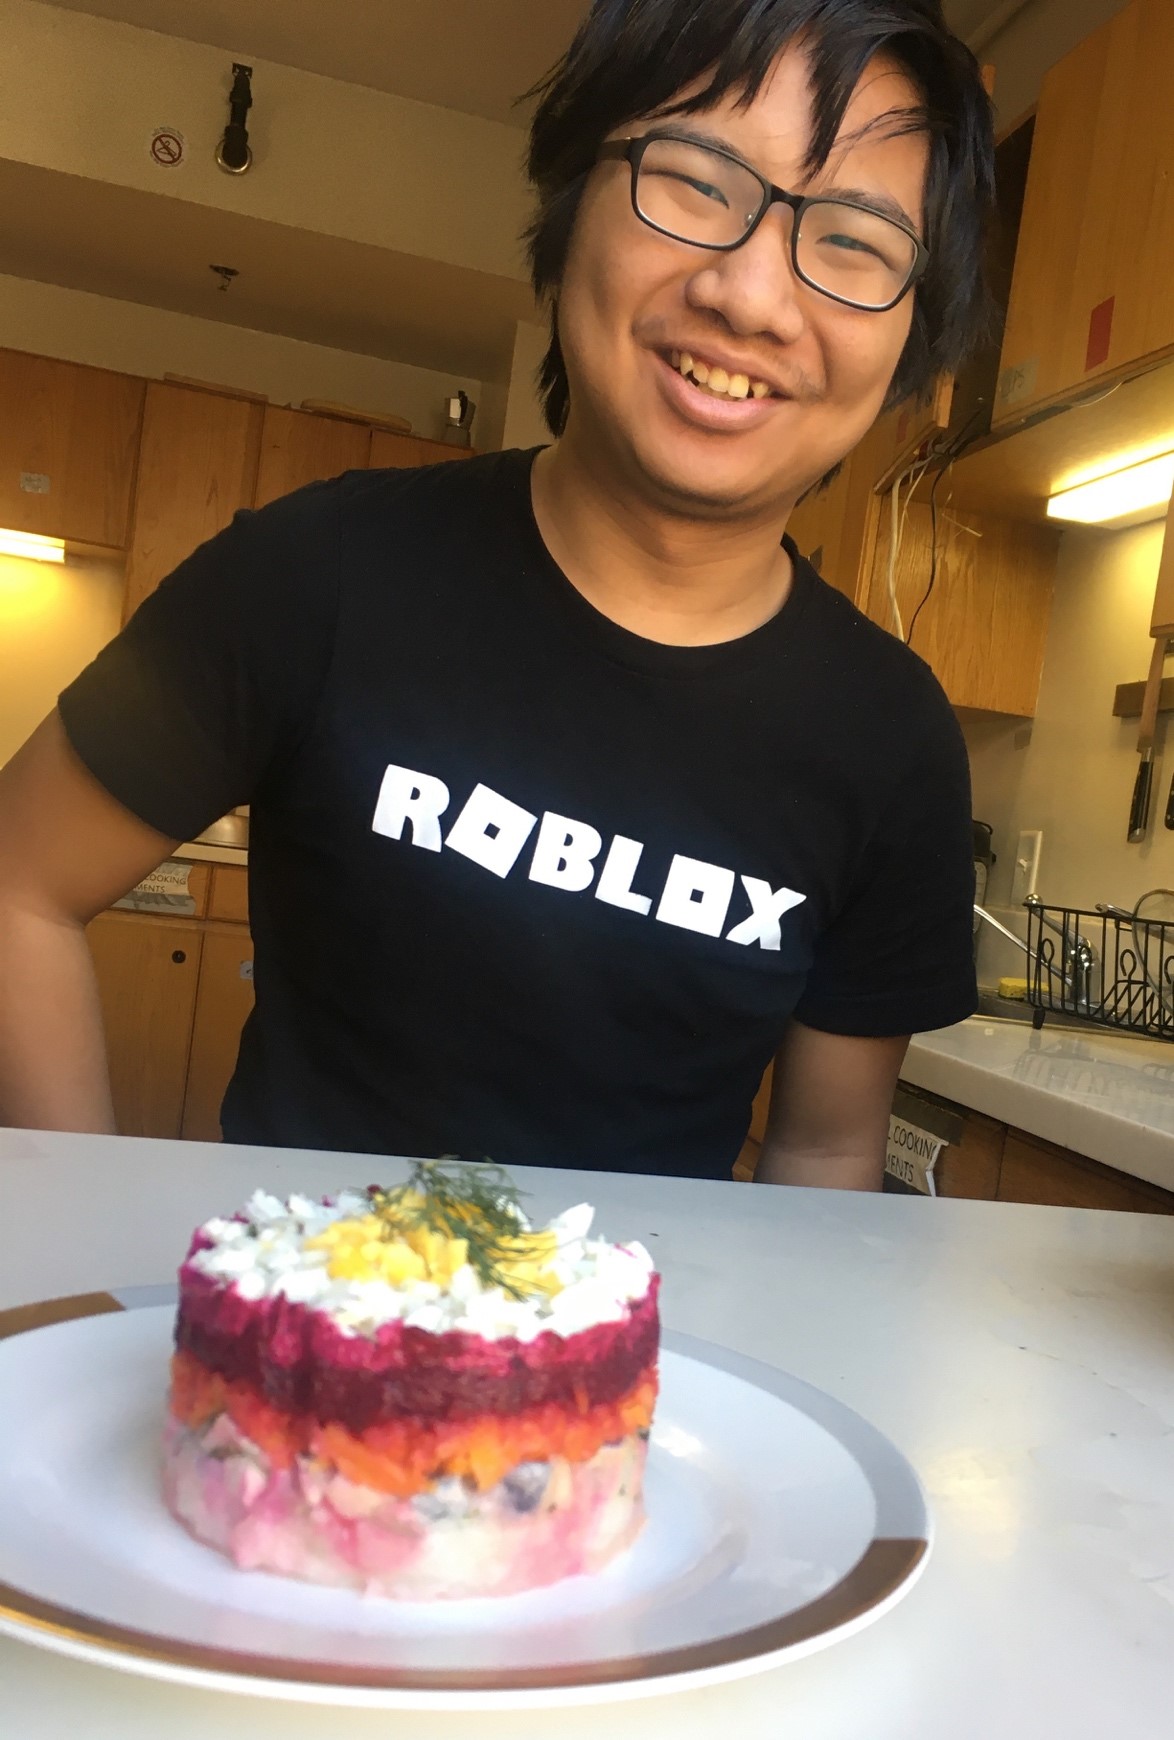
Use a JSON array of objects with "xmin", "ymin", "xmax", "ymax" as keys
[{"xmin": 0, "ymin": 273, "xmax": 482, "ymax": 445}]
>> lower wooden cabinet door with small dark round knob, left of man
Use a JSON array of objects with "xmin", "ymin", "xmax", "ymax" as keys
[{"xmin": 87, "ymin": 912, "xmax": 202, "ymax": 1136}]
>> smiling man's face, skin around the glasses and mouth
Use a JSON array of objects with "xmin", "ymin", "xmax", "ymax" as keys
[{"xmin": 558, "ymin": 45, "xmax": 929, "ymax": 517}]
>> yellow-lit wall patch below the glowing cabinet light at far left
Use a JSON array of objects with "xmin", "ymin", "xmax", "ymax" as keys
[{"xmin": 0, "ymin": 542, "xmax": 123, "ymax": 766}]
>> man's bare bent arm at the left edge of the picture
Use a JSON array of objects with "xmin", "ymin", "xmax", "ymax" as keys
[{"xmin": 0, "ymin": 712, "xmax": 176, "ymax": 1131}]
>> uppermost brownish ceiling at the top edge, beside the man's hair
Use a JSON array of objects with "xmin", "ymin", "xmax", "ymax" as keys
[{"xmin": 36, "ymin": 0, "xmax": 1012, "ymax": 127}]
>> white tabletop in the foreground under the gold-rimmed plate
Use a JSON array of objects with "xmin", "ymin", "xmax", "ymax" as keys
[{"xmin": 0, "ymin": 1134, "xmax": 1174, "ymax": 1740}]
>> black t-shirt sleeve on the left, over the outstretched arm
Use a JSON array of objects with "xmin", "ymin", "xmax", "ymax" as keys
[{"xmin": 57, "ymin": 484, "xmax": 339, "ymax": 840}]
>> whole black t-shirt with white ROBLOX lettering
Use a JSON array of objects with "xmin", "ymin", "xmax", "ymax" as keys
[{"xmin": 61, "ymin": 452, "xmax": 974, "ymax": 1178}]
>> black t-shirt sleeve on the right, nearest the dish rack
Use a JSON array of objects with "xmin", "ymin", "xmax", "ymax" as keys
[{"xmin": 795, "ymin": 673, "xmax": 977, "ymax": 1039}]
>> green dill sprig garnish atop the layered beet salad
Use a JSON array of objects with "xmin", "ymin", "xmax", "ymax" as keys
[{"xmin": 367, "ymin": 1154, "xmax": 541, "ymax": 1300}]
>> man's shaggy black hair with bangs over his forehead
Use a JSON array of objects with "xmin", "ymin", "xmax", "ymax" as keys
[{"xmin": 525, "ymin": 0, "xmax": 995, "ymax": 435}]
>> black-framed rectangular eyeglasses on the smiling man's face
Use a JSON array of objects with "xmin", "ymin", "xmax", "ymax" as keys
[{"xmin": 598, "ymin": 132, "xmax": 929, "ymax": 313}]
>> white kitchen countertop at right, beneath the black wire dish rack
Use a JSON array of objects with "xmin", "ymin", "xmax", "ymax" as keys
[{"xmin": 901, "ymin": 1014, "xmax": 1174, "ymax": 1190}]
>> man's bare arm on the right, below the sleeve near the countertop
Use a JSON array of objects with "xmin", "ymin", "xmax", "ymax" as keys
[{"xmin": 755, "ymin": 1021, "xmax": 910, "ymax": 1190}]
